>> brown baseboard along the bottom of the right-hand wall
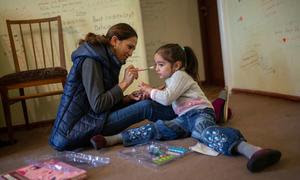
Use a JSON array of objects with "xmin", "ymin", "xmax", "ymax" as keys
[{"xmin": 231, "ymin": 88, "xmax": 300, "ymax": 102}]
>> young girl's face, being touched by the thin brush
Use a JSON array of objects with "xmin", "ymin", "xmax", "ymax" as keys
[{"xmin": 154, "ymin": 53, "xmax": 177, "ymax": 79}]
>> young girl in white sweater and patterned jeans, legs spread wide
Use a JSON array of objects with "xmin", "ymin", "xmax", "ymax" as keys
[{"xmin": 91, "ymin": 44, "xmax": 281, "ymax": 172}]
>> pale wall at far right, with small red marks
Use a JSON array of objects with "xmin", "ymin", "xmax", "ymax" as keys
[{"xmin": 218, "ymin": 0, "xmax": 300, "ymax": 96}]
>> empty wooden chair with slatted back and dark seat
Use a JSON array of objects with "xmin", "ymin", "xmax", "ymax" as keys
[{"xmin": 0, "ymin": 16, "xmax": 67, "ymax": 143}]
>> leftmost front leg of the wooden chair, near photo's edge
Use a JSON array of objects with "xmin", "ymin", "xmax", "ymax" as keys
[{"xmin": 1, "ymin": 89, "xmax": 16, "ymax": 144}]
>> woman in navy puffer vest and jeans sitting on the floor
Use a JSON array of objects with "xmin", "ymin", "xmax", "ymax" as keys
[{"xmin": 49, "ymin": 23, "xmax": 176, "ymax": 151}]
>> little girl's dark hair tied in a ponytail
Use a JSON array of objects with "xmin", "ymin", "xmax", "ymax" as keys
[{"xmin": 155, "ymin": 44, "xmax": 200, "ymax": 85}]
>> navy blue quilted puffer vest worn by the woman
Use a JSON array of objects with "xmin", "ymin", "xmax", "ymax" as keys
[{"xmin": 49, "ymin": 43, "xmax": 121, "ymax": 151}]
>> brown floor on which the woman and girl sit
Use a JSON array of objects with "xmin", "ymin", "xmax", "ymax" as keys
[{"xmin": 0, "ymin": 87, "xmax": 300, "ymax": 180}]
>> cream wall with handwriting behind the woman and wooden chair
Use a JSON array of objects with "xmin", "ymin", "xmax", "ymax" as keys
[{"xmin": 0, "ymin": 0, "xmax": 148, "ymax": 127}]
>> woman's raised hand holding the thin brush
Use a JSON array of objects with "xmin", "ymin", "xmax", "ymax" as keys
[{"xmin": 119, "ymin": 65, "xmax": 139, "ymax": 91}]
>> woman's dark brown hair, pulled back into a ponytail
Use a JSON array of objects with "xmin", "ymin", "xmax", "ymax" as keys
[{"xmin": 79, "ymin": 23, "xmax": 138, "ymax": 45}]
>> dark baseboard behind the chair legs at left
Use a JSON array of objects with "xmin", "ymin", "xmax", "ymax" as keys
[{"xmin": 0, "ymin": 119, "xmax": 54, "ymax": 134}]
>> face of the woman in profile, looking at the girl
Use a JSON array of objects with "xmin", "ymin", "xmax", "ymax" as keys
[{"xmin": 111, "ymin": 36, "xmax": 137, "ymax": 62}]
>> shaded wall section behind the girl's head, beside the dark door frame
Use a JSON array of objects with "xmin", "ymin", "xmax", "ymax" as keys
[{"xmin": 141, "ymin": 0, "xmax": 205, "ymax": 85}]
